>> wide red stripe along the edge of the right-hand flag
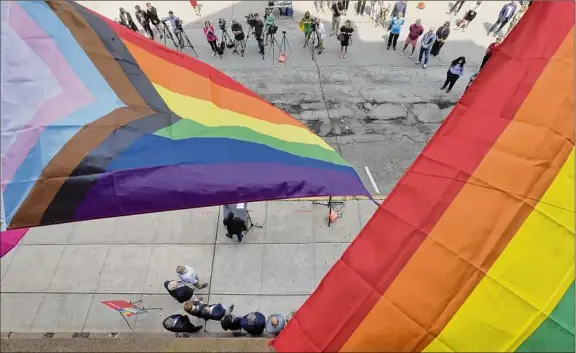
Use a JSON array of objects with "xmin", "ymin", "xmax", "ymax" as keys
[{"xmin": 273, "ymin": 2, "xmax": 573, "ymax": 351}]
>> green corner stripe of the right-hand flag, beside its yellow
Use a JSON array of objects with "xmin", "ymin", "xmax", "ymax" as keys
[{"xmin": 517, "ymin": 283, "xmax": 575, "ymax": 352}]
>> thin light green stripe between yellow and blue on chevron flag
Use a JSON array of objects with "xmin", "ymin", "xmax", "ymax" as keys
[{"xmin": 155, "ymin": 119, "xmax": 349, "ymax": 167}]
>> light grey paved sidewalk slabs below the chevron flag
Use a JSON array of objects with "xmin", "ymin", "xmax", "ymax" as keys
[{"xmin": 0, "ymin": 200, "xmax": 376, "ymax": 332}]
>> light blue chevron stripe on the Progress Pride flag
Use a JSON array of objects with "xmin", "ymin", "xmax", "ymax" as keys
[{"xmin": 4, "ymin": 1, "xmax": 126, "ymax": 224}]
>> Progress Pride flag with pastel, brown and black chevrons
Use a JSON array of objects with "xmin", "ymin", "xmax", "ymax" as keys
[{"xmin": 0, "ymin": 1, "xmax": 369, "ymax": 234}]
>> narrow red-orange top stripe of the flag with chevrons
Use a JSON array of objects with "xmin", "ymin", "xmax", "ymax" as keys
[{"xmin": 83, "ymin": 5, "xmax": 267, "ymax": 102}]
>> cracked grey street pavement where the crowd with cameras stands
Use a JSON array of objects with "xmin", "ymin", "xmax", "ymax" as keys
[{"xmin": 79, "ymin": 1, "xmax": 506, "ymax": 195}]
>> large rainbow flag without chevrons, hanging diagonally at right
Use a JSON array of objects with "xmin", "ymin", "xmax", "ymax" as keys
[{"xmin": 273, "ymin": 1, "xmax": 575, "ymax": 352}]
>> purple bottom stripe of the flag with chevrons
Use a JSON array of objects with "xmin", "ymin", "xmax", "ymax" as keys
[{"xmin": 74, "ymin": 163, "xmax": 369, "ymax": 221}]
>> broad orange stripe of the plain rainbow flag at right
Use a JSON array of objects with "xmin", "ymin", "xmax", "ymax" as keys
[{"xmin": 341, "ymin": 28, "xmax": 574, "ymax": 351}]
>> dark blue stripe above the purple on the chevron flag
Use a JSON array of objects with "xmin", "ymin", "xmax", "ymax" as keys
[{"xmin": 107, "ymin": 131, "xmax": 356, "ymax": 175}]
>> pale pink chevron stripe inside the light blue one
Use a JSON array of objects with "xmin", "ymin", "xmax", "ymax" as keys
[{"xmin": 2, "ymin": 1, "xmax": 94, "ymax": 190}]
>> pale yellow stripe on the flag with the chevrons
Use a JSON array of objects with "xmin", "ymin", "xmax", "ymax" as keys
[{"xmin": 153, "ymin": 83, "xmax": 333, "ymax": 151}]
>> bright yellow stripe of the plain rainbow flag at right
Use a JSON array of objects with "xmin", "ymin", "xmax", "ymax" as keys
[{"xmin": 425, "ymin": 151, "xmax": 574, "ymax": 352}]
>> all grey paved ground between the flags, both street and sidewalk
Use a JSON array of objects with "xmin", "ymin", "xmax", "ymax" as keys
[{"xmin": 0, "ymin": 1, "xmax": 504, "ymax": 332}]
